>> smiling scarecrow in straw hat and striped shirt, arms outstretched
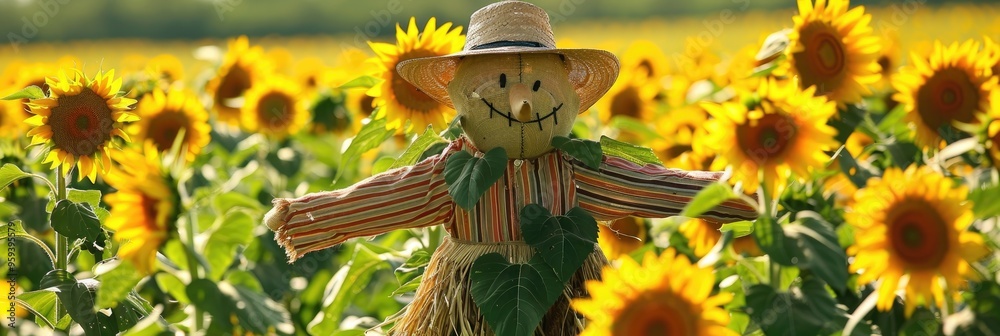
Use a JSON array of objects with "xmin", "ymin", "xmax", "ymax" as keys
[{"xmin": 265, "ymin": 1, "xmax": 756, "ymax": 335}]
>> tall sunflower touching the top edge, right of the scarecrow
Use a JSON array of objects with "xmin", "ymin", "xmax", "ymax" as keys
[{"xmin": 788, "ymin": 0, "xmax": 880, "ymax": 104}]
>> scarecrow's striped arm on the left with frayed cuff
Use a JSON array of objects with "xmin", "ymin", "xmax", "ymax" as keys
[{"xmin": 264, "ymin": 154, "xmax": 452, "ymax": 261}]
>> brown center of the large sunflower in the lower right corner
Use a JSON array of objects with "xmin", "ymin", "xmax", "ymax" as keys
[{"xmin": 888, "ymin": 202, "xmax": 948, "ymax": 269}]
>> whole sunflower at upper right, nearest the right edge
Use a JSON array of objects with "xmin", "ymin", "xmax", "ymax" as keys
[{"xmin": 892, "ymin": 40, "xmax": 997, "ymax": 149}]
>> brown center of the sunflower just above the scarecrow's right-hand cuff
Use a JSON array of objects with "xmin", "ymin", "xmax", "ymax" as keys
[{"xmin": 736, "ymin": 113, "xmax": 795, "ymax": 164}]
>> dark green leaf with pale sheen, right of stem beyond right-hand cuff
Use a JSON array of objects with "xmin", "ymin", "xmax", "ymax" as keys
[{"xmin": 784, "ymin": 211, "xmax": 848, "ymax": 292}]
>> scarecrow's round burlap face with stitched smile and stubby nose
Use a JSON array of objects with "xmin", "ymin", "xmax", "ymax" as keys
[{"xmin": 448, "ymin": 54, "xmax": 580, "ymax": 159}]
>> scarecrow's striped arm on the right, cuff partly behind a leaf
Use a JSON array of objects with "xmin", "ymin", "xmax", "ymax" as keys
[{"xmin": 573, "ymin": 156, "xmax": 757, "ymax": 223}]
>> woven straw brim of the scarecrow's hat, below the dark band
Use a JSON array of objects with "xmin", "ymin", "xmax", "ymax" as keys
[{"xmin": 396, "ymin": 46, "xmax": 620, "ymax": 113}]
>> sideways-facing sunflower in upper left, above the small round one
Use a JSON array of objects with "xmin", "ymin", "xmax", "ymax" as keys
[{"xmin": 205, "ymin": 36, "xmax": 271, "ymax": 125}]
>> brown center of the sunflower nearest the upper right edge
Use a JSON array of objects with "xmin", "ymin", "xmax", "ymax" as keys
[{"xmin": 917, "ymin": 68, "xmax": 979, "ymax": 130}]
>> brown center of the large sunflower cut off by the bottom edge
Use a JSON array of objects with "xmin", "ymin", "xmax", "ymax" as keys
[{"xmin": 612, "ymin": 292, "xmax": 698, "ymax": 336}]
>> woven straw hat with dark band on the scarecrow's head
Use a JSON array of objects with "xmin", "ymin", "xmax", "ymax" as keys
[{"xmin": 396, "ymin": 1, "xmax": 619, "ymax": 112}]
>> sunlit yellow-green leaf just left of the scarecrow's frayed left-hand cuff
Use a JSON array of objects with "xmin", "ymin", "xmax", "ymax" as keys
[{"xmin": 205, "ymin": 211, "xmax": 257, "ymax": 280}]
